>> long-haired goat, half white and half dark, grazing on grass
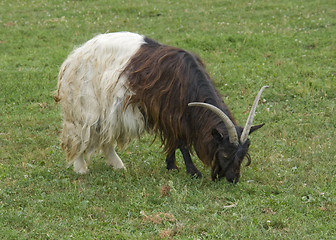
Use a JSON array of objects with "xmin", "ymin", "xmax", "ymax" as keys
[{"xmin": 55, "ymin": 32, "xmax": 266, "ymax": 182}]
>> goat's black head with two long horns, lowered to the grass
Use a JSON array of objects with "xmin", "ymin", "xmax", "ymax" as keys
[{"xmin": 188, "ymin": 86, "xmax": 268, "ymax": 183}]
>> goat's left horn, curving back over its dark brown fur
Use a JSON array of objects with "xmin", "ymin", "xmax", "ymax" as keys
[{"xmin": 188, "ymin": 102, "xmax": 239, "ymax": 146}]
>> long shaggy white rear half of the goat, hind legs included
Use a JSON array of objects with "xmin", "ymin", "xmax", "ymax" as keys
[{"xmin": 58, "ymin": 32, "xmax": 145, "ymax": 173}]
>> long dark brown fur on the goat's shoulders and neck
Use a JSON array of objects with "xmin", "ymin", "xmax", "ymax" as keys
[{"xmin": 124, "ymin": 38, "xmax": 234, "ymax": 168}]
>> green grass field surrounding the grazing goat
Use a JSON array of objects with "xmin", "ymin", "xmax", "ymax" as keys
[{"xmin": 0, "ymin": 0, "xmax": 336, "ymax": 239}]
